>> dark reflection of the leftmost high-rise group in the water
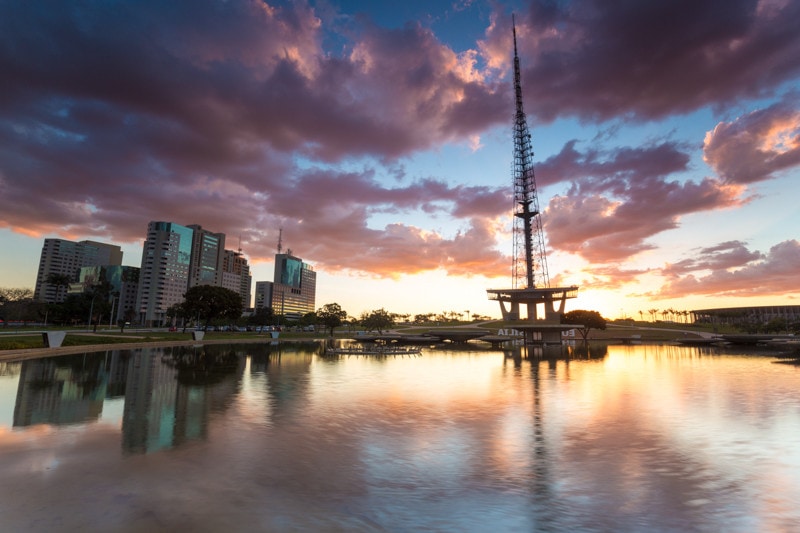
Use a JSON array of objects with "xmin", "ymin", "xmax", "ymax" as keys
[{"xmin": 13, "ymin": 346, "xmax": 246, "ymax": 453}]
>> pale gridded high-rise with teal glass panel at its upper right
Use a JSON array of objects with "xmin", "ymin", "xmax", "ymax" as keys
[{"xmin": 136, "ymin": 221, "xmax": 194, "ymax": 325}]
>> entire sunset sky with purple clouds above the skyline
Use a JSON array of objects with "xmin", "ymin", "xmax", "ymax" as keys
[{"xmin": 0, "ymin": 0, "xmax": 800, "ymax": 318}]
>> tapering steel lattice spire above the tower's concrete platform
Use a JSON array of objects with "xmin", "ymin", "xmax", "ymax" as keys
[{"xmin": 511, "ymin": 18, "xmax": 550, "ymax": 289}]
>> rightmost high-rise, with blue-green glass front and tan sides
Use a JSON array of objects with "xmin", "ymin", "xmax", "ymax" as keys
[{"xmin": 271, "ymin": 251, "xmax": 317, "ymax": 316}]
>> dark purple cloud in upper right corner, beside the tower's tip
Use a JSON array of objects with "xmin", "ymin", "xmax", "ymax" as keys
[{"xmin": 483, "ymin": 0, "xmax": 800, "ymax": 121}]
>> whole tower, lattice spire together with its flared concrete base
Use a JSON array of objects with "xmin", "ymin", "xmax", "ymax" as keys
[{"xmin": 486, "ymin": 19, "xmax": 578, "ymax": 323}]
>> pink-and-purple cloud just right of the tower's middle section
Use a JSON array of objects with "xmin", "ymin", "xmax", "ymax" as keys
[{"xmin": 537, "ymin": 142, "xmax": 744, "ymax": 263}]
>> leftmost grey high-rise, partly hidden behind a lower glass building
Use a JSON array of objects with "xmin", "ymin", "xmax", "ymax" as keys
[{"xmin": 33, "ymin": 239, "xmax": 122, "ymax": 303}]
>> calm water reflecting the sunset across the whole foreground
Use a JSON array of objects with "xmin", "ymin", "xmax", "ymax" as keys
[{"xmin": 0, "ymin": 343, "xmax": 800, "ymax": 532}]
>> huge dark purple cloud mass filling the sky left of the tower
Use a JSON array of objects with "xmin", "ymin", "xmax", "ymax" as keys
[{"xmin": 0, "ymin": 1, "xmax": 505, "ymax": 272}]
